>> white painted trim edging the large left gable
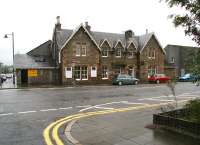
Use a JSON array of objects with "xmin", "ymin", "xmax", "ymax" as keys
[{"xmin": 59, "ymin": 23, "xmax": 101, "ymax": 63}]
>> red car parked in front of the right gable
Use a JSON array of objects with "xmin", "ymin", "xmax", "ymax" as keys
[{"xmin": 148, "ymin": 74, "xmax": 170, "ymax": 84}]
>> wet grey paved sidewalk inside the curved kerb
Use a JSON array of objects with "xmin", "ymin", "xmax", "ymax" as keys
[{"xmin": 68, "ymin": 109, "xmax": 200, "ymax": 145}]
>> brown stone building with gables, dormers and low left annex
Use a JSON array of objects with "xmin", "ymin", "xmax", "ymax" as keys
[{"xmin": 14, "ymin": 16, "xmax": 165, "ymax": 85}]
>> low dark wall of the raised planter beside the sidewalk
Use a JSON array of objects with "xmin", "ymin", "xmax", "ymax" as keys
[{"xmin": 153, "ymin": 109, "xmax": 200, "ymax": 137}]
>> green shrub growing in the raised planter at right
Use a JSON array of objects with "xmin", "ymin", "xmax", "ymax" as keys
[{"xmin": 185, "ymin": 100, "xmax": 200, "ymax": 123}]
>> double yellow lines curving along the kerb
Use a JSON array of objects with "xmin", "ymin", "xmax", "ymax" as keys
[{"xmin": 43, "ymin": 100, "xmax": 188, "ymax": 145}]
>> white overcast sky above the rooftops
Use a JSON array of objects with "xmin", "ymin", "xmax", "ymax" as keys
[{"xmin": 0, "ymin": 0, "xmax": 196, "ymax": 64}]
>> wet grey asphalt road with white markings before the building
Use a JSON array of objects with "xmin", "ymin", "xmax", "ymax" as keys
[{"xmin": 0, "ymin": 83, "xmax": 200, "ymax": 145}]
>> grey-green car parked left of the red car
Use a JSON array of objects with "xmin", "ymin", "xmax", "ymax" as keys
[{"xmin": 112, "ymin": 74, "xmax": 139, "ymax": 86}]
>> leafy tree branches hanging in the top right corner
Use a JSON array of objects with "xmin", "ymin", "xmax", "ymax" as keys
[{"xmin": 161, "ymin": 0, "xmax": 200, "ymax": 45}]
